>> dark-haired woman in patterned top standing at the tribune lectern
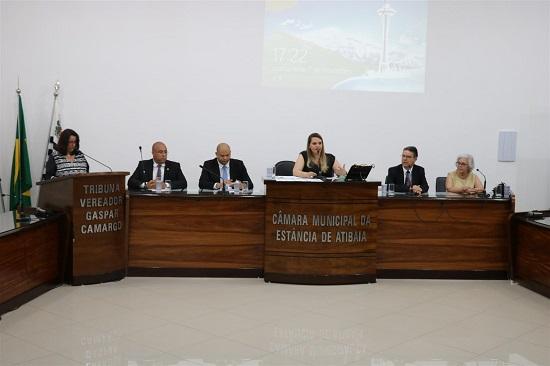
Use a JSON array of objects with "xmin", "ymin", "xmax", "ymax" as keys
[{"xmin": 44, "ymin": 128, "xmax": 90, "ymax": 179}]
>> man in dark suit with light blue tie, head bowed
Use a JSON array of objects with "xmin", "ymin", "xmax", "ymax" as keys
[{"xmin": 199, "ymin": 142, "xmax": 254, "ymax": 189}]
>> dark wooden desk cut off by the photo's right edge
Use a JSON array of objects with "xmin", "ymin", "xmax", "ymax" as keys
[{"xmin": 512, "ymin": 211, "xmax": 550, "ymax": 297}]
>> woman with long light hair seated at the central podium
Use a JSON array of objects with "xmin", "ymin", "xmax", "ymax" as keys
[{"xmin": 292, "ymin": 132, "xmax": 346, "ymax": 178}]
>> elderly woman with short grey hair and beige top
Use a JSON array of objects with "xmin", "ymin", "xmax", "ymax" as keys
[{"xmin": 445, "ymin": 154, "xmax": 483, "ymax": 194}]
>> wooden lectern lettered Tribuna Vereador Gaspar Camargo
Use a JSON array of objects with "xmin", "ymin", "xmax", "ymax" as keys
[{"xmin": 37, "ymin": 172, "xmax": 128, "ymax": 285}]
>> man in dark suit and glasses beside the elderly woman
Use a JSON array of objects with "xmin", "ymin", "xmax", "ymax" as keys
[{"xmin": 386, "ymin": 146, "xmax": 430, "ymax": 194}]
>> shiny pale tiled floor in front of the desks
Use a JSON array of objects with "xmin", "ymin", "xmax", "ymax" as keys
[{"xmin": 0, "ymin": 278, "xmax": 550, "ymax": 366}]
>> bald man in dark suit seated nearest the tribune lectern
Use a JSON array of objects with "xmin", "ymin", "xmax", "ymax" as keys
[{"xmin": 128, "ymin": 141, "xmax": 187, "ymax": 189}]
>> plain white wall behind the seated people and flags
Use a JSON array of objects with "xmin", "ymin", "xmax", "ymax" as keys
[{"xmin": 0, "ymin": 1, "xmax": 550, "ymax": 211}]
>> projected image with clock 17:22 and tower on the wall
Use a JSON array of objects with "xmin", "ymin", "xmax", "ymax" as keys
[{"xmin": 263, "ymin": 0, "xmax": 427, "ymax": 93}]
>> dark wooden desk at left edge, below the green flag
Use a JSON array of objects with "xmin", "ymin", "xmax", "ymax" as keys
[{"xmin": 0, "ymin": 212, "xmax": 67, "ymax": 315}]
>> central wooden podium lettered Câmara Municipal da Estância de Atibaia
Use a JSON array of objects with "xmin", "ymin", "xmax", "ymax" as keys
[{"xmin": 264, "ymin": 181, "xmax": 380, "ymax": 284}]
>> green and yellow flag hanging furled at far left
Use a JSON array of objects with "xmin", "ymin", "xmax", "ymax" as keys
[{"xmin": 10, "ymin": 94, "xmax": 32, "ymax": 214}]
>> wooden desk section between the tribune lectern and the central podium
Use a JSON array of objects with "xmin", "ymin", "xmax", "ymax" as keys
[{"xmin": 128, "ymin": 191, "xmax": 265, "ymax": 277}]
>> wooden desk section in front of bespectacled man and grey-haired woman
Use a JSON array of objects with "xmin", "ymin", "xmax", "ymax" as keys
[{"xmin": 377, "ymin": 194, "xmax": 514, "ymax": 279}]
